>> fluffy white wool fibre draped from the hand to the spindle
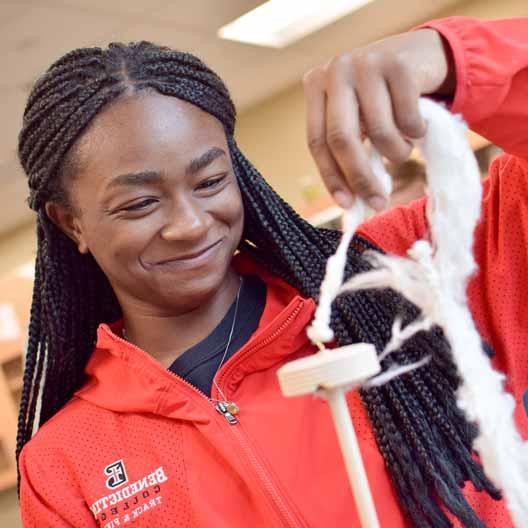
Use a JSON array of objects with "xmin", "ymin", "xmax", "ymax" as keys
[{"xmin": 308, "ymin": 99, "xmax": 528, "ymax": 528}]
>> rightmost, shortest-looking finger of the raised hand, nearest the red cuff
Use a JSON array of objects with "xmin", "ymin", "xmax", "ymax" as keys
[{"xmin": 386, "ymin": 64, "xmax": 426, "ymax": 139}]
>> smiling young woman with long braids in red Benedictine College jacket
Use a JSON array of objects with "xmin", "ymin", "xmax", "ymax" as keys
[{"xmin": 17, "ymin": 14, "xmax": 528, "ymax": 528}]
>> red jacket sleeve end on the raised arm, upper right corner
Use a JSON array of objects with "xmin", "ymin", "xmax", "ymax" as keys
[{"xmin": 421, "ymin": 17, "xmax": 528, "ymax": 158}]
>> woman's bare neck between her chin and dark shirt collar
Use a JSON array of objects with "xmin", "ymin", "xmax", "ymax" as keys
[{"xmin": 119, "ymin": 269, "xmax": 240, "ymax": 367}]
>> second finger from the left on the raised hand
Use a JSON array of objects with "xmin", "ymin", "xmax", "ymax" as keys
[{"xmin": 326, "ymin": 61, "xmax": 384, "ymax": 208}]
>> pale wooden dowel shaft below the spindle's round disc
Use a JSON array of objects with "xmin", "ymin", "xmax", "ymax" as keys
[{"xmin": 325, "ymin": 387, "xmax": 380, "ymax": 528}]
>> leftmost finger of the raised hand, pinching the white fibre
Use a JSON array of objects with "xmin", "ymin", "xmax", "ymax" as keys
[{"xmin": 303, "ymin": 69, "xmax": 352, "ymax": 209}]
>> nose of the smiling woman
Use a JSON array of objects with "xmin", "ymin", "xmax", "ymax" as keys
[{"xmin": 160, "ymin": 195, "xmax": 210, "ymax": 242}]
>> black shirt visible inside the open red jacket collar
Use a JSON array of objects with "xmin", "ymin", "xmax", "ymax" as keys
[{"xmin": 169, "ymin": 275, "xmax": 266, "ymax": 396}]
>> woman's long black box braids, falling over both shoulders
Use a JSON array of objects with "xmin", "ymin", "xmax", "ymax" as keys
[{"xmin": 16, "ymin": 42, "xmax": 500, "ymax": 528}]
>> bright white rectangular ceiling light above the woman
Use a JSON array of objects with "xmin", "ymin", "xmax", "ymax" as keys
[{"xmin": 218, "ymin": 0, "xmax": 372, "ymax": 48}]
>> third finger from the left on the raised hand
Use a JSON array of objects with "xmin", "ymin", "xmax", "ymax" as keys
[{"xmin": 356, "ymin": 64, "xmax": 412, "ymax": 163}]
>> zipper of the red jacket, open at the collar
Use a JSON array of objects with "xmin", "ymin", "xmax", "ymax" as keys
[{"xmin": 106, "ymin": 301, "xmax": 304, "ymax": 528}]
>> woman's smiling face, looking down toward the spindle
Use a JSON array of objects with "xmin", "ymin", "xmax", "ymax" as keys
[{"xmin": 46, "ymin": 91, "xmax": 244, "ymax": 315}]
